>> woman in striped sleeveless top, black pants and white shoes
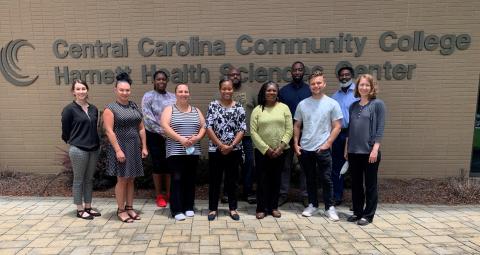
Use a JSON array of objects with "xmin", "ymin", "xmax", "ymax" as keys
[{"xmin": 160, "ymin": 84, "xmax": 205, "ymax": 220}]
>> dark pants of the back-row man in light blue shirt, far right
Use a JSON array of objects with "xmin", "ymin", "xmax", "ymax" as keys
[{"xmin": 332, "ymin": 131, "xmax": 347, "ymax": 201}]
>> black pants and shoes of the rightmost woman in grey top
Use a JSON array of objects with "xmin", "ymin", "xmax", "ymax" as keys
[{"xmin": 348, "ymin": 152, "xmax": 381, "ymax": 222}]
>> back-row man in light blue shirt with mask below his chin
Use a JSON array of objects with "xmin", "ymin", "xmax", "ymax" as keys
[{"xmin": 332, "ymin": 66, "xmax": 358, "ymax": 206}]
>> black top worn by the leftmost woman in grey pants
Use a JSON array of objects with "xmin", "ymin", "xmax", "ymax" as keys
[{"xmin": 62, "ymin": 101, "xmax": 100, "ymax": 151}]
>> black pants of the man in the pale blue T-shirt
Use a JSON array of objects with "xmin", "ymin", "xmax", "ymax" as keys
[{"xmin": 298, "ymin": 150, "xmax": 333, "ymax": 210}]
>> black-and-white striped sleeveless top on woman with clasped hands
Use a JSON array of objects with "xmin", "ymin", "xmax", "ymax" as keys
[{"xmin": 166, "ymin": 104, "xmax": 202, "ymax": 158}]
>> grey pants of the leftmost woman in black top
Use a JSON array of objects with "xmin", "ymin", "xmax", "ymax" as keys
[{"xmin": 68, "ymin": 145, "xmax": 100, "ymax": 205}]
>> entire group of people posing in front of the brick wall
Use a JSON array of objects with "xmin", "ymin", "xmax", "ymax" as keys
[{"xmin": 62, "ymin": 61, "xmax": 385, "ymax": 225}]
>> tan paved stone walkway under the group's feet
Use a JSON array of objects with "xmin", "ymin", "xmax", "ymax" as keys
[{"xmin": 0, "ymin": 197, "xmax": 480, "ymax": 255}]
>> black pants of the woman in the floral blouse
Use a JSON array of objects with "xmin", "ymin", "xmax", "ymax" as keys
[{"xmin": 208, "ymin": 150, "xmax": 242, "ymax": 211}]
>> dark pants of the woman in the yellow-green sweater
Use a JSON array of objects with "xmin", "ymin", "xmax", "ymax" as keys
[{"xmin": 255, "ymin": 149, "xmax": 285, "ymax": 213}]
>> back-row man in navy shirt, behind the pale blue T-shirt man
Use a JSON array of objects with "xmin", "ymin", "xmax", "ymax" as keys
[{"xmin": 278, "ymin": 61, "xmax": 312, "ymax": 206}]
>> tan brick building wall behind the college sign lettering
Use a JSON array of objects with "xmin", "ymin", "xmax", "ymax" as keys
[{"xmin": 0, "ymin": 0, "xmax": 480, "ymax": 178}]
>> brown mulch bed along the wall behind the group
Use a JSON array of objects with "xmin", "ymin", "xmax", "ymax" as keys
[{"xmin": 0, "ymin": 172, "xmax": 480, "ymax": 205}]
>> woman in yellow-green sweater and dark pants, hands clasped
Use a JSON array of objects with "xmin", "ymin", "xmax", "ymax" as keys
[{"xmin": 250, "ymin": 81, "xmax": 293, "ymax": 219}]
